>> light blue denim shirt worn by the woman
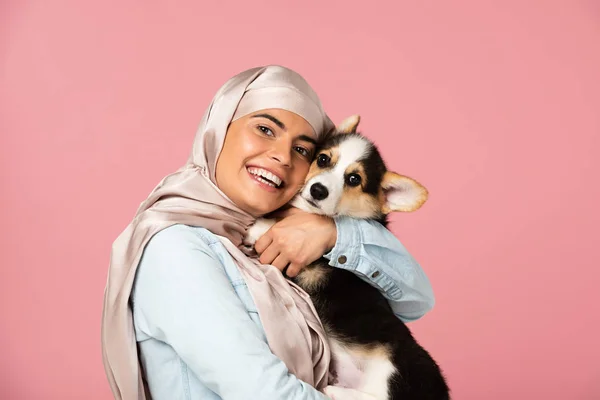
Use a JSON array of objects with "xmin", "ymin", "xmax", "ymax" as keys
[{"xmin": 131, "ymin": 217, "xmax": 434, "ymax": 400}]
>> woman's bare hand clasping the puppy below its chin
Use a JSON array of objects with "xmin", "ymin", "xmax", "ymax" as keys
[{"xmin": 254, "ymin": 208, "xmax": 337, "ymax": 278}]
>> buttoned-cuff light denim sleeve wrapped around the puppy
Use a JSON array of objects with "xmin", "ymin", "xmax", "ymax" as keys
[{"xmin": 325, "ymin": 217, "xmax": 435, "ymax": 322}]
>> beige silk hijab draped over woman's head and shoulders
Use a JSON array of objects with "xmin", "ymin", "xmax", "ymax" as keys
[{"xmin": 102, "ymin": 66, "xmax": 334, "ymax": 400}]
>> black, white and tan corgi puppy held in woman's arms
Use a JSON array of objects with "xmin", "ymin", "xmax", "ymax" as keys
[{"xmin": 244, "ymin": 115, "xmax": 450, "ymax": 400}]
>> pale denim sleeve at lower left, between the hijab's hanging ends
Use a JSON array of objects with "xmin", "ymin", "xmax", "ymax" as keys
[{"xmin": 132, "ymin": 226, "xmax": 327, "ymax": 400}]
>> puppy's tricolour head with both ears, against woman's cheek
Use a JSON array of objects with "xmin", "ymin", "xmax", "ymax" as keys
[{"xmin": 292, "ymin": 115, "xmax": 428, "ymax": 220}]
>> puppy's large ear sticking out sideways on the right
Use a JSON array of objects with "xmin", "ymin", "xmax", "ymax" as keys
[{"xmin": 381, "ymin": 171, "xmax": 429, "ymax": 214}]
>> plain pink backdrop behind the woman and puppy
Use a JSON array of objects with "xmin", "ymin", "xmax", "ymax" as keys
[{"xmin": 0, "ymin": 0, "xmax": 600, "ymax": 400}]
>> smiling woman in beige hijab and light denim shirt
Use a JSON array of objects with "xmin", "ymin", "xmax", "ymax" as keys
[{"xmin": 102, "ymin": 66, "xmax": 433, "ymax": 399}]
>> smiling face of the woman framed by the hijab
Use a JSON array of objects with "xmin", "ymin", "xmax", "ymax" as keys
[{"xmin": 216, "ymin": 109, "xmax": 317, "ymax": 217}]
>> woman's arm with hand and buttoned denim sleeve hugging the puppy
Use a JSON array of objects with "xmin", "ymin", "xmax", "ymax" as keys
[{"xmin": 255, "ymin": 209, "xmax": 435, "ymax": 322}]
